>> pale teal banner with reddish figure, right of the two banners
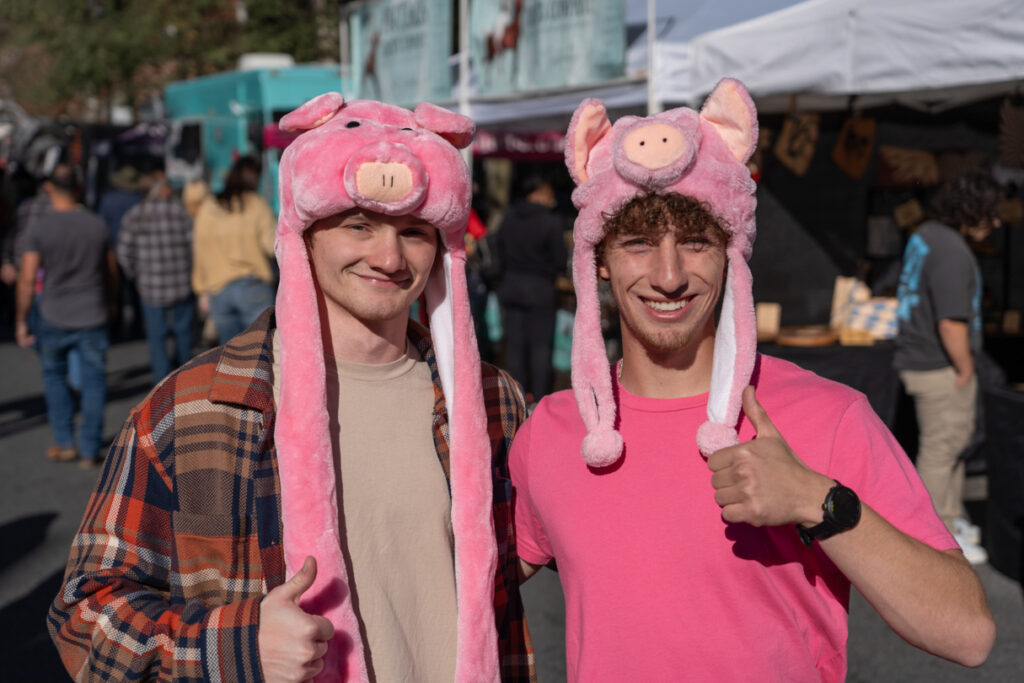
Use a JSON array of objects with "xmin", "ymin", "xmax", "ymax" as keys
[{"xmin": 469, "ymin": 0, "xmax": 626, "ymax": 95}]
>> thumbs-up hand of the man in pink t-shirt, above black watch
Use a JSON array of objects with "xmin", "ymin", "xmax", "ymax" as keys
[{"xmin": 708, "ymin": 386, "xmax": 835, "ymax": 526}]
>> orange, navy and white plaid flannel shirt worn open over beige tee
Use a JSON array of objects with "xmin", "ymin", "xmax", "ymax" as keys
[{"xmin": 47, "ymin": 310, "xmax": 536, "ymax": 681}]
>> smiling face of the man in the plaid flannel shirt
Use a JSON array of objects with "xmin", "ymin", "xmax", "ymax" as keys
[{"xmin": 306, "ymin": 210, "xmax": 438, "ymax": 327}]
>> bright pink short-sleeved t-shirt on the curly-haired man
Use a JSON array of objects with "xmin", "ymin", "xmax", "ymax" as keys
[{"xmin": 510, "ymin": 356, "xmax": 956, "ymax": 683}]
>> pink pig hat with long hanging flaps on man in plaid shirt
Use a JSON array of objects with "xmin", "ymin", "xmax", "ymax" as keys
[{"xmin": 274, "ymin": 92, "xmax": 499, "ymax": 681}]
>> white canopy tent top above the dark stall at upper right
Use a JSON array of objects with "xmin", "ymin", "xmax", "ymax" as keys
[{"xmin": 679, "ymin": 0, "xmax": 1024, "ymax": 113}]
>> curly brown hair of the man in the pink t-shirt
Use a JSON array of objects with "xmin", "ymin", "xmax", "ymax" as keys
[{"xmin": 597, "ymin": 193, "xmax": 729, "ymax": 257}]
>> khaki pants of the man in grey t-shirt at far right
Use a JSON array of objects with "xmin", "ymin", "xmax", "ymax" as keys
[{"xmin": 899, "ymin": 368, "xmax": 978, "ymax": 531}]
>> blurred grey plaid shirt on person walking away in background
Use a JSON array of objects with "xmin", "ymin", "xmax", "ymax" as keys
[{"xmin": 117, "ymin": 198, "xmax": 193, "ymax": 306}]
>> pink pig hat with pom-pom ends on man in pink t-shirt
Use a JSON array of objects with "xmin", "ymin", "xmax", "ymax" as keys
[{"xmin": 565, "ymin": 78, "xmax": 758, "ymax": 467}]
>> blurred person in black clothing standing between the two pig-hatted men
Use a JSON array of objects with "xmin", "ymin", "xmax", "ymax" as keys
[{"xmin": 497, "ymin": 175, "xmax": 567, "ymax": 400}]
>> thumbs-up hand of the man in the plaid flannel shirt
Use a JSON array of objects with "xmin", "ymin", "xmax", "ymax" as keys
[{"xmin": 257, "ymin": 557, "xmax": 334, "ymax": 683}]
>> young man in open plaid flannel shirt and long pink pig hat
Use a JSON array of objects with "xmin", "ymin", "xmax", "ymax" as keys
[{"xmin": 48, "ymin": 93, "xmax": 532, "ymax": 681}]
